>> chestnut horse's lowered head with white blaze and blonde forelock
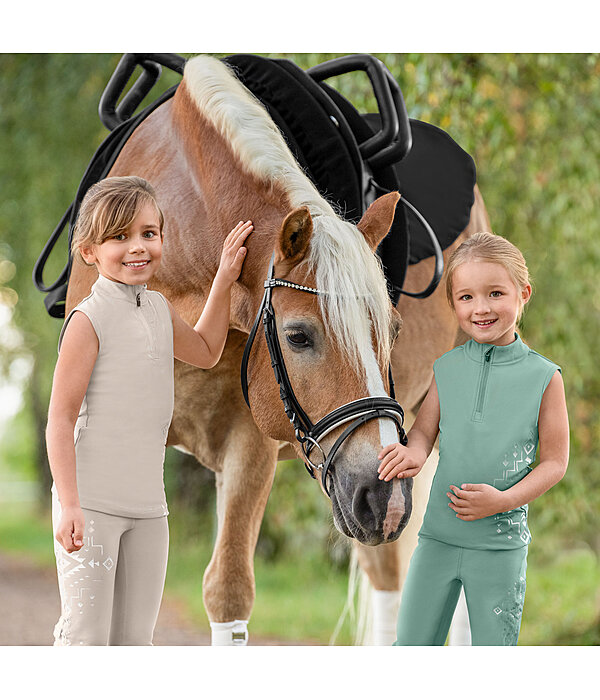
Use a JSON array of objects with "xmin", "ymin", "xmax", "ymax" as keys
[{"xmin": 249, "ymin": 193, "xmax": 412, "ymax": 545}]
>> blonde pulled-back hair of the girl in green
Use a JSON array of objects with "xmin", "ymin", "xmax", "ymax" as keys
[{"xmin": 446, "ymin": 232, "xmax": 531, "ymax": 322}]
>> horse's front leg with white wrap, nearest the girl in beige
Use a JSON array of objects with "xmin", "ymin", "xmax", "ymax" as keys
[{"xmin": 203, "ymin": 431, "xmax": 278, "ymax": 646}]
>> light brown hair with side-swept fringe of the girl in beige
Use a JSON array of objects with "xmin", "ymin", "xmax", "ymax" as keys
[{"xmin": 71, "ymin": 175, "xmax": 165, "ymax": 262}]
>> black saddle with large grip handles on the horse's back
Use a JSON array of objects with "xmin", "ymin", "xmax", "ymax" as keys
[{"xmin": 33, "ymin": 54, "xmax": 476, "ymax": 318}]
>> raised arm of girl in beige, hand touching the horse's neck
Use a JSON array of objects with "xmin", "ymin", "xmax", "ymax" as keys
[{"xmin": 168, "ymin": 221, "xmax": 253, "ymax": 369}]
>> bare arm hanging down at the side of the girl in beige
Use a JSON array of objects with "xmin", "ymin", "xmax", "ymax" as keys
[{"xmin": 46, "ymin": 312, "xmax": 98, "ymax": 552}]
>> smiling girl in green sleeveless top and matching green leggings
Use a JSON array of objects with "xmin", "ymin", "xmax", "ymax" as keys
[{"xmin": 378, "ymin": 233, "xmax": 569, "ymax": 646}]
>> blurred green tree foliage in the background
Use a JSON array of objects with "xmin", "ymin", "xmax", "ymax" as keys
[{"xmin": 0, "ymin": 54, "xmax": 600, "ymax": 644}]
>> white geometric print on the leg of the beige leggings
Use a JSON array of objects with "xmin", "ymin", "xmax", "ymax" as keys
[{"xmin": 54, "ymin": 520, "xmax": 110, "ymax": 646}]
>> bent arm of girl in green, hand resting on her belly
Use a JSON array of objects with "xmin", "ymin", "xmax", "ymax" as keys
[{"xmin": 447, "ymin": 370, "xmax": 569, "ymax": 520}]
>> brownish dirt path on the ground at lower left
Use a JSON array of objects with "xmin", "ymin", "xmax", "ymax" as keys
[{"xmin": 0, "ymin": 552, "xmax": 302, "ymax": 646}]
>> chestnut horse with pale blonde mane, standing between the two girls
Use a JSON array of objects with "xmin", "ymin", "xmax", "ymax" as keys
[{"xmin": 66, "ymin": 56, "xmax": 485, "ymax": 645}]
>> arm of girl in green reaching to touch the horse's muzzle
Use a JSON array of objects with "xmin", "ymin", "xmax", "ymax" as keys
[{"xmin": 377, "ymin": 376, "xmax": 440, "ymax": 481}]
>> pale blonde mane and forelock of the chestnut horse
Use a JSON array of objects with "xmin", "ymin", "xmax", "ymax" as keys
[{"xmin": 184, "ymin": 56, "xmax": 391, "ymax": 378}]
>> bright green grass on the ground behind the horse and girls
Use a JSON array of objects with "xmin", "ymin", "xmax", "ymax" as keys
[{"xmin": 0, "ymin": 506, "xmax": 600, "ymax": 646}]
